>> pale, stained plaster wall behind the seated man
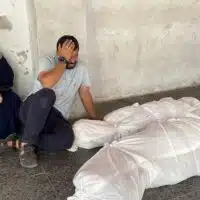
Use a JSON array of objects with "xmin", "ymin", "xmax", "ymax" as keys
[{"xmin": 0, "ymin": 0, "xmax": 200, "ymax": 115}]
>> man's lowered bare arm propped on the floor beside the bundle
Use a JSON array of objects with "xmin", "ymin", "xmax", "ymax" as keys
[{"xmin": 79, "ymin": 86, "xmax": 97, "ymax": 119}]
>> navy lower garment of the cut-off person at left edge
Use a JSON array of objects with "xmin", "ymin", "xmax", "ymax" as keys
[{"xmin": 0, "ymin": 90, "xmax": 21, "ymax": 139}]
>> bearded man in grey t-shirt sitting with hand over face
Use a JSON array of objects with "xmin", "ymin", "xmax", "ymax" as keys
[{"xmin": 5, "ymin": 35, "xmax": 97, "ymax": 168}]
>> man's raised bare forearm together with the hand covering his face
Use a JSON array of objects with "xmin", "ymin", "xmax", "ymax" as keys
[{"xmin": 38, "ymin": 40, "xmax": 75, "ymax": 88}]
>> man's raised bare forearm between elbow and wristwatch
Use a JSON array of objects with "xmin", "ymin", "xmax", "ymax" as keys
[{"xmin": 38, "ymin": 63, "xmax": 66, "ymax": 88}]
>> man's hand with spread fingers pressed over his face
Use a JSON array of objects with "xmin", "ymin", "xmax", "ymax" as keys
[{"xmin": 58, "ymin": 40, "xmax": 75, "ymax": 62}]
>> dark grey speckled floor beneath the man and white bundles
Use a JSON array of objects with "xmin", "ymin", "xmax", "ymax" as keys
[{"xmin": 0, "ymin": 87, "xmax": 200, "ymax": 200}]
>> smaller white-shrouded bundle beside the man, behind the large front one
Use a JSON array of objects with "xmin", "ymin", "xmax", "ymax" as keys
[{"xmin": 73, "ymin": 97, "xmax": 197, "ymax": 150}]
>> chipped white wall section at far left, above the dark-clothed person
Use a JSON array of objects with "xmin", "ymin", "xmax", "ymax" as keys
[{"xmin": 0, "ymin": 0, "xmax": 38, "ymax": 97}]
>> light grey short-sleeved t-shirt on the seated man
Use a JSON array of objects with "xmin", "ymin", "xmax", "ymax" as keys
[{"xmin": 32, "ymin": 56, "xmax": 90, "ymax": 119}]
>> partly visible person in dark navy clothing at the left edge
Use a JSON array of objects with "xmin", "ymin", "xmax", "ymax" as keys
[{"xmin": 0, "ymin": 56, "xmax": 21, "ymax": 150}]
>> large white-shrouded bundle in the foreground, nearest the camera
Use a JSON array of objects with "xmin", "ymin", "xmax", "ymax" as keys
[{"xmin": 68, "ymin": 118, "xmax": 200, "ymax": 200}]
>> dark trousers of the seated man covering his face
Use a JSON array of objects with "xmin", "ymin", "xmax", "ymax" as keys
[{"xmin": 20, "ymin": 88, "xmax": 74, "ymax": 152}]
